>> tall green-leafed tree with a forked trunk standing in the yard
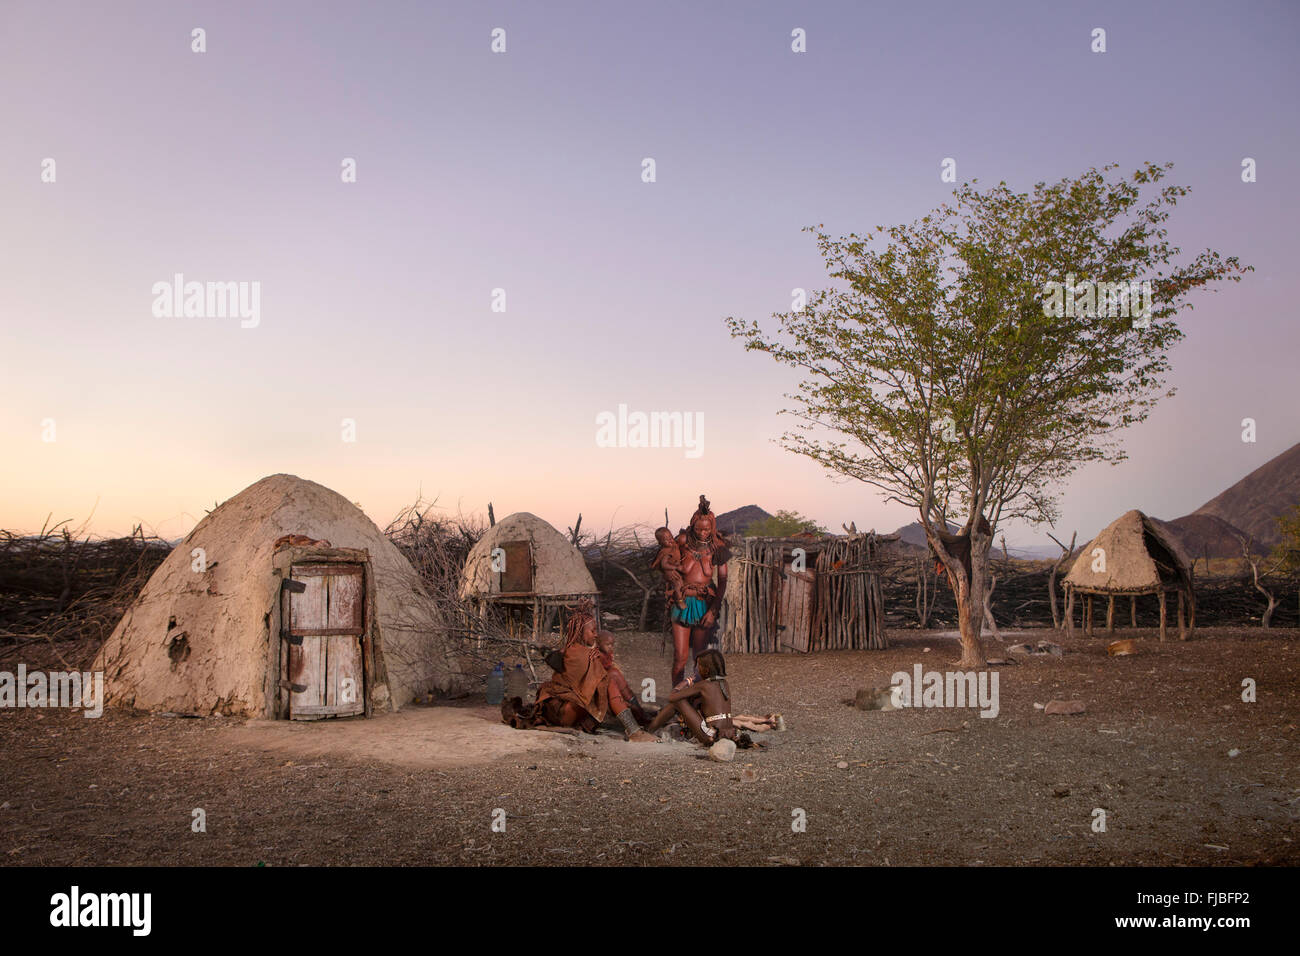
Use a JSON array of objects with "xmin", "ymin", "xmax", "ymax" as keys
[{"xmin": 727, "ymin": 164, "xmax": 1248, "ymax": 667}]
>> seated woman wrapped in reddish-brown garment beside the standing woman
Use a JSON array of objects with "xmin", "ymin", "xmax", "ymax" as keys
[{"xmin": 501, "ymin": 600, "xmax": 657, "ymax": 743}]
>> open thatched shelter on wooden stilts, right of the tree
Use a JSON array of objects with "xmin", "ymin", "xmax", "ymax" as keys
[{"xmin": 1065, "ymin": 510, "xmax": 1196, "ymax": 640}]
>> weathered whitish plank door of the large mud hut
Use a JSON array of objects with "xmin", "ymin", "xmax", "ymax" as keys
[{"xmin": 286, "ymin": 564, "xmax": 365, "ymax": 721}]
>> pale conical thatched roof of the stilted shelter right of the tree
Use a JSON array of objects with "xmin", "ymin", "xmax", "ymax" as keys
[{"xmin": 1065, "ymin": 509, "xmax": 1192, "ymax": 594}]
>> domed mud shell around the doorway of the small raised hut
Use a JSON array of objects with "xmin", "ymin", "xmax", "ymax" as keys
[{"xmin": 460, "ymin": 511, "xmax": 597, "ymax": 598}]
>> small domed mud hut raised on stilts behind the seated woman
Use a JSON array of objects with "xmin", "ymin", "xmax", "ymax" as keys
[{"xmin": 460, "ymin": 511, "xmax": 599, "ymax": 640}]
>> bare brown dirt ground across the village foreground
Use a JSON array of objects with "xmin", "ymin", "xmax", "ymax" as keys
[{"xmin": 0, "ymin": 631, "xmax": 1300, "ymax": 865}]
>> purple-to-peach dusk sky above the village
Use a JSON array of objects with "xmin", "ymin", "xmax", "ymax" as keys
[{"xmin": 0, "ymin": 0, "xmax": 1300, "ymax": 545}]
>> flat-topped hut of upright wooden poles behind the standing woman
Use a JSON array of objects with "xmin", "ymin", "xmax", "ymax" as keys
[{"xmin": 719, "ymin": 532, "xmax": 888, "ymax": 654}]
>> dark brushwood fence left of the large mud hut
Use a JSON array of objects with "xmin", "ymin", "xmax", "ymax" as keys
[{"xmin": 0, "ymin": 520, "xmax": 172, "ymax": 667}]
